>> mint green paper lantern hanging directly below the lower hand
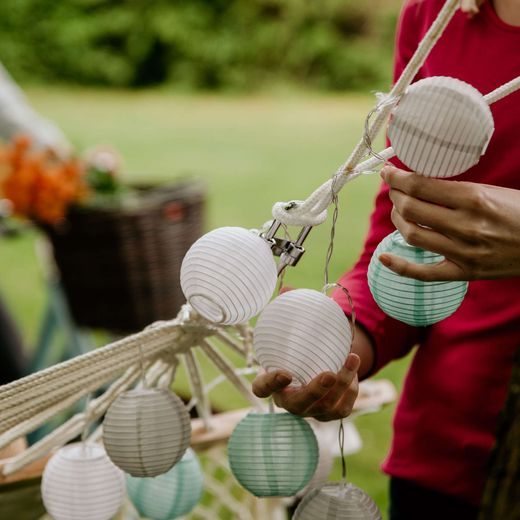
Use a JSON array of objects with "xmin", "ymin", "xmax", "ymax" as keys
[{"xmin": 228, "ymin": 413, "xmax": 318, "ymax": 497}]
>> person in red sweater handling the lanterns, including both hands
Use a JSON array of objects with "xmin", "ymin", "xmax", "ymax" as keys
[{"xmin": 253, "ymin": 0, "xmax": 520, "ymax": 520}]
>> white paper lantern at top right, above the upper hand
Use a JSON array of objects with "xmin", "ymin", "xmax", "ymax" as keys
[{"xmin": 388, "ymin": 76, "xmax": 494, "ymax": 177}]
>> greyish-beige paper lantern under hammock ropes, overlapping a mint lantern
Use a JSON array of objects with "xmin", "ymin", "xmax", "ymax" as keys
[{"xmin": 103, "ymin": 388, "xmax": 191, "ymax": 477}]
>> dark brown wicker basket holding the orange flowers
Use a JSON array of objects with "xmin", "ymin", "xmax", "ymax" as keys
[{"xmin": 47, "ymin": 181, "xmax": 205, "ymax": 333}]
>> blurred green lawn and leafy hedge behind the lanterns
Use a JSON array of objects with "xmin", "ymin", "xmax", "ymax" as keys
[{"xmin": 0, "ymin": 0, "xmax": 408, "ymax": 515}]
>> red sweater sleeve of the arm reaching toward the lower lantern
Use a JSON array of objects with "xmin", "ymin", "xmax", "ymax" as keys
[{"xmin": 334, "ymin": 0, "xmax": 422, "ymax": 373}]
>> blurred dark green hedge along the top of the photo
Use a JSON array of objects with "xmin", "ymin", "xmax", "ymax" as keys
[{"xmin": 0, "ymin": 0, "xmax": 401, "ymax": 91}]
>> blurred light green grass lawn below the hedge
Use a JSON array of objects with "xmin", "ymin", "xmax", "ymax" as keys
[{"xmin": 0, "ymin": 88, "xmax": 407, "ymax": 513}]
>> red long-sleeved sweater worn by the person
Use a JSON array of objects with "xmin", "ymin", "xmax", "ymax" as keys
[{"xmin": 335, "ymin": 0, "xmax": 520, "ymax": 504}]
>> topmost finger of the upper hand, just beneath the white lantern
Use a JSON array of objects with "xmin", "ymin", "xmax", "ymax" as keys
[{"xmin": 381, "ymin": 166, "xmax": 472, "ymax": 208}]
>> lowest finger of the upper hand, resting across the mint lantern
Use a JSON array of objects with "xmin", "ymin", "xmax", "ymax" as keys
[{"xmin": 379, "ymin": 253, "xmax": 468, "ymax": 282}]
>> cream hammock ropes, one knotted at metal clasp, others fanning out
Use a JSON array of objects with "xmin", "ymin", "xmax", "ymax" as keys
[{"xmin": 0, "ymin": 0, "xmax": 520, "ymax": 516}]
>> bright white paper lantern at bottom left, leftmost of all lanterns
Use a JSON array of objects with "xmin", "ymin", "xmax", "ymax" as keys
[{"xmin": 42, "ymin": 443, "xmax": 125, "ymax": 520}]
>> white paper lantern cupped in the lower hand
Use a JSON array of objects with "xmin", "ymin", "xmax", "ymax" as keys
[{"xmin": 253, "ymin": 289, "xmax": 352, "ymax": 385}]
